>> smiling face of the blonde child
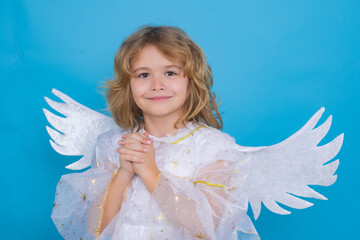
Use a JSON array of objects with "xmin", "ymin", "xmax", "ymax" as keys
[{"xmin": 130, "ymin": 45, "xmax": 189, "ymax": 121}]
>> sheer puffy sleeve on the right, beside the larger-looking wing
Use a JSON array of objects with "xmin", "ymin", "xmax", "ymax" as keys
[{"xmin": 151, "ymin": 143, "xmax": 258, "ymax": 239}]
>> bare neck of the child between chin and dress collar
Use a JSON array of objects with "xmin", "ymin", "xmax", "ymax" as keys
[{"xmin": 144, "ymin": 116, "xmax": 188, "ymax": 137}]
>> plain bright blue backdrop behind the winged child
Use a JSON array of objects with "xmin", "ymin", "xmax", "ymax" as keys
[{"xmin": 0, "ymin": 0, "xmax": 360, "ymax": 240}]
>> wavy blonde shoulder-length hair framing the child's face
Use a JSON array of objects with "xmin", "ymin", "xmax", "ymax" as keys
[{"xmin": 103, "ymin": 25, "xmax": 222, "ymax": 132}]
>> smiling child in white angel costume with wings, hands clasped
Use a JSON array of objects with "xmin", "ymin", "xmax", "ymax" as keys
[{"xmin": 45, "ymin": 26, "xmax": 342, "ymax": 239}]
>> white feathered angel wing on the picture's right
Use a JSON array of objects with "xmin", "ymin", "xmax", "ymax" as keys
[{"xmin": 239, "ymin": 108, "xmax": 344, "ymax": 219}]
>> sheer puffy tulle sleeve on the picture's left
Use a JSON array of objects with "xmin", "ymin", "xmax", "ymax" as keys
[{"xmin": 51, "ymin": 130, "xmax": 119, "ymax": 239}]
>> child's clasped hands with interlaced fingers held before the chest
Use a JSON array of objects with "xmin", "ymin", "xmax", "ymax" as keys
[{"xmin": 116, "ymin": 132, "xmax": 160, "ymax": 191}]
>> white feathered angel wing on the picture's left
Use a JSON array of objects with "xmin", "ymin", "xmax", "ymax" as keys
[{"xmin": 43, "ymin": 89, "xmax": 119, "ymax": 170}]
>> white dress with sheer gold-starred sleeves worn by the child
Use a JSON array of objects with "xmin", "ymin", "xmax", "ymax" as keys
[{"xmin": 51, "ymin": 122, "xmax": 259, "ymax": 240}]
